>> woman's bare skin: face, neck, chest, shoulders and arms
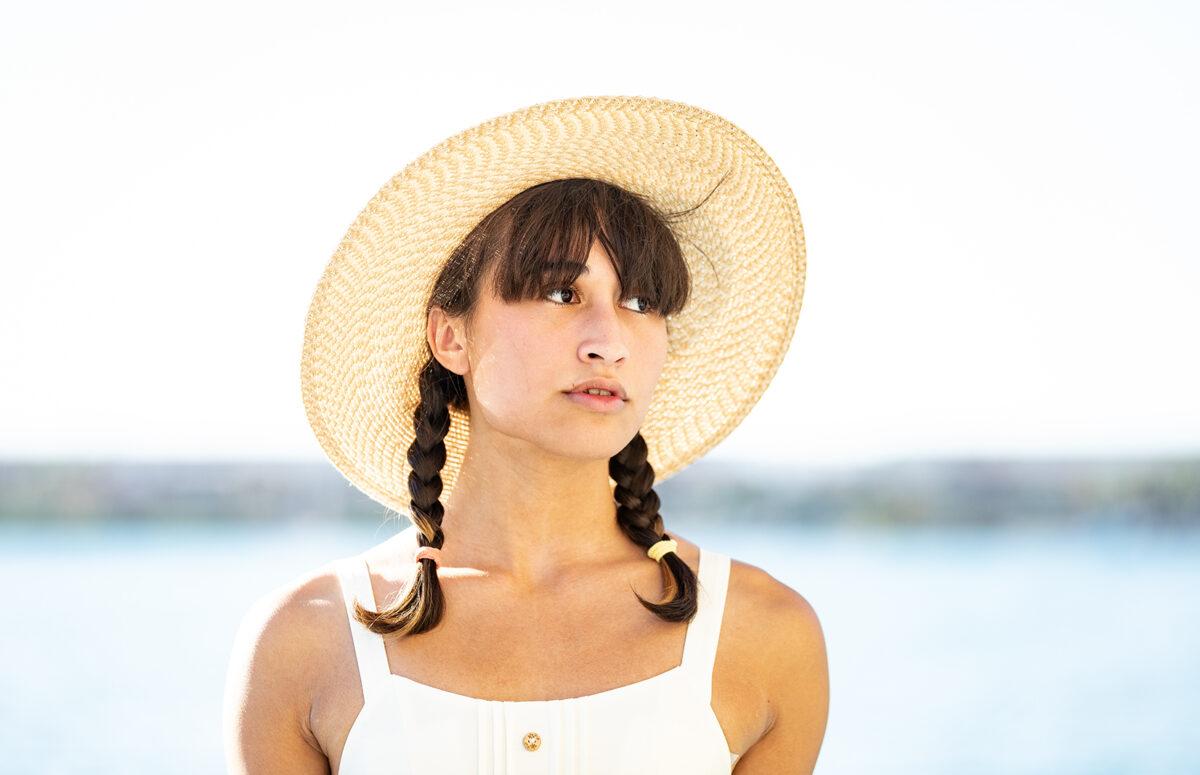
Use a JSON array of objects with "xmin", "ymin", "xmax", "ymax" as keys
[{"xmin": 224, "ymin": 236, "xmax": 829, "ymax": 775}]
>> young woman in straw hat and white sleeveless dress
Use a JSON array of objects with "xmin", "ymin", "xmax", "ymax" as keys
[{"xmin": 224, "ymin": 97, "xmax": 828, "ymax": 775}]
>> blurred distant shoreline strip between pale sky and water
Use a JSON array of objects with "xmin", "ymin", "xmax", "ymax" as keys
[{"xmin": 0, "ymin": 453, "xmax": 1200, "ymax": 528}]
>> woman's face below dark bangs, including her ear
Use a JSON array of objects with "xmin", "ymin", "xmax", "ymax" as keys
[{"xmin": 431, "ymin": 241, "xmax": 667, "ymax": 459}]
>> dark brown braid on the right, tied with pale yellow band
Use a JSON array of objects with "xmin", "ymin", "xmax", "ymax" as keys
[{"xmin": 608, "ymin": 433, "xmax": 696, "ymax": 621}]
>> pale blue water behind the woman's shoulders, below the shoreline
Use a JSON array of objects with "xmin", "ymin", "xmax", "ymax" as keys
[{"xmin": 0, "ymin": 521, "xmax": 1200, "ymax": 775}]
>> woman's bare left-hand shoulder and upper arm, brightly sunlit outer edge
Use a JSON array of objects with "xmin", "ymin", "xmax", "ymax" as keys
[{"xmin": 222, "ymin": 563, "xmax": 349, "ymax": 775}]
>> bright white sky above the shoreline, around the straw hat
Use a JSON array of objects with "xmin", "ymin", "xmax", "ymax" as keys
[{"xmin": 0, "ymin": 0, "xmax": 1200, "ymax": 463}]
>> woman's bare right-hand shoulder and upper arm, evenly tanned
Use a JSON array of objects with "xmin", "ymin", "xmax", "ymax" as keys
[{"xmin": 727, "ymin": 560, "xmax": 829, "ymax": 774}]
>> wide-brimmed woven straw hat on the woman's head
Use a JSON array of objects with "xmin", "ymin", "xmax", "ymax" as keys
[{"xmin": 300, "ymin": 96, "xmax": 805, "ymax": 513}]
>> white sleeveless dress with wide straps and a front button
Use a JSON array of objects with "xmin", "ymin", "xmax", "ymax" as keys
[{"xmin": 337, "ymin": 548, "xmax": 738, "ymax": 775}]
